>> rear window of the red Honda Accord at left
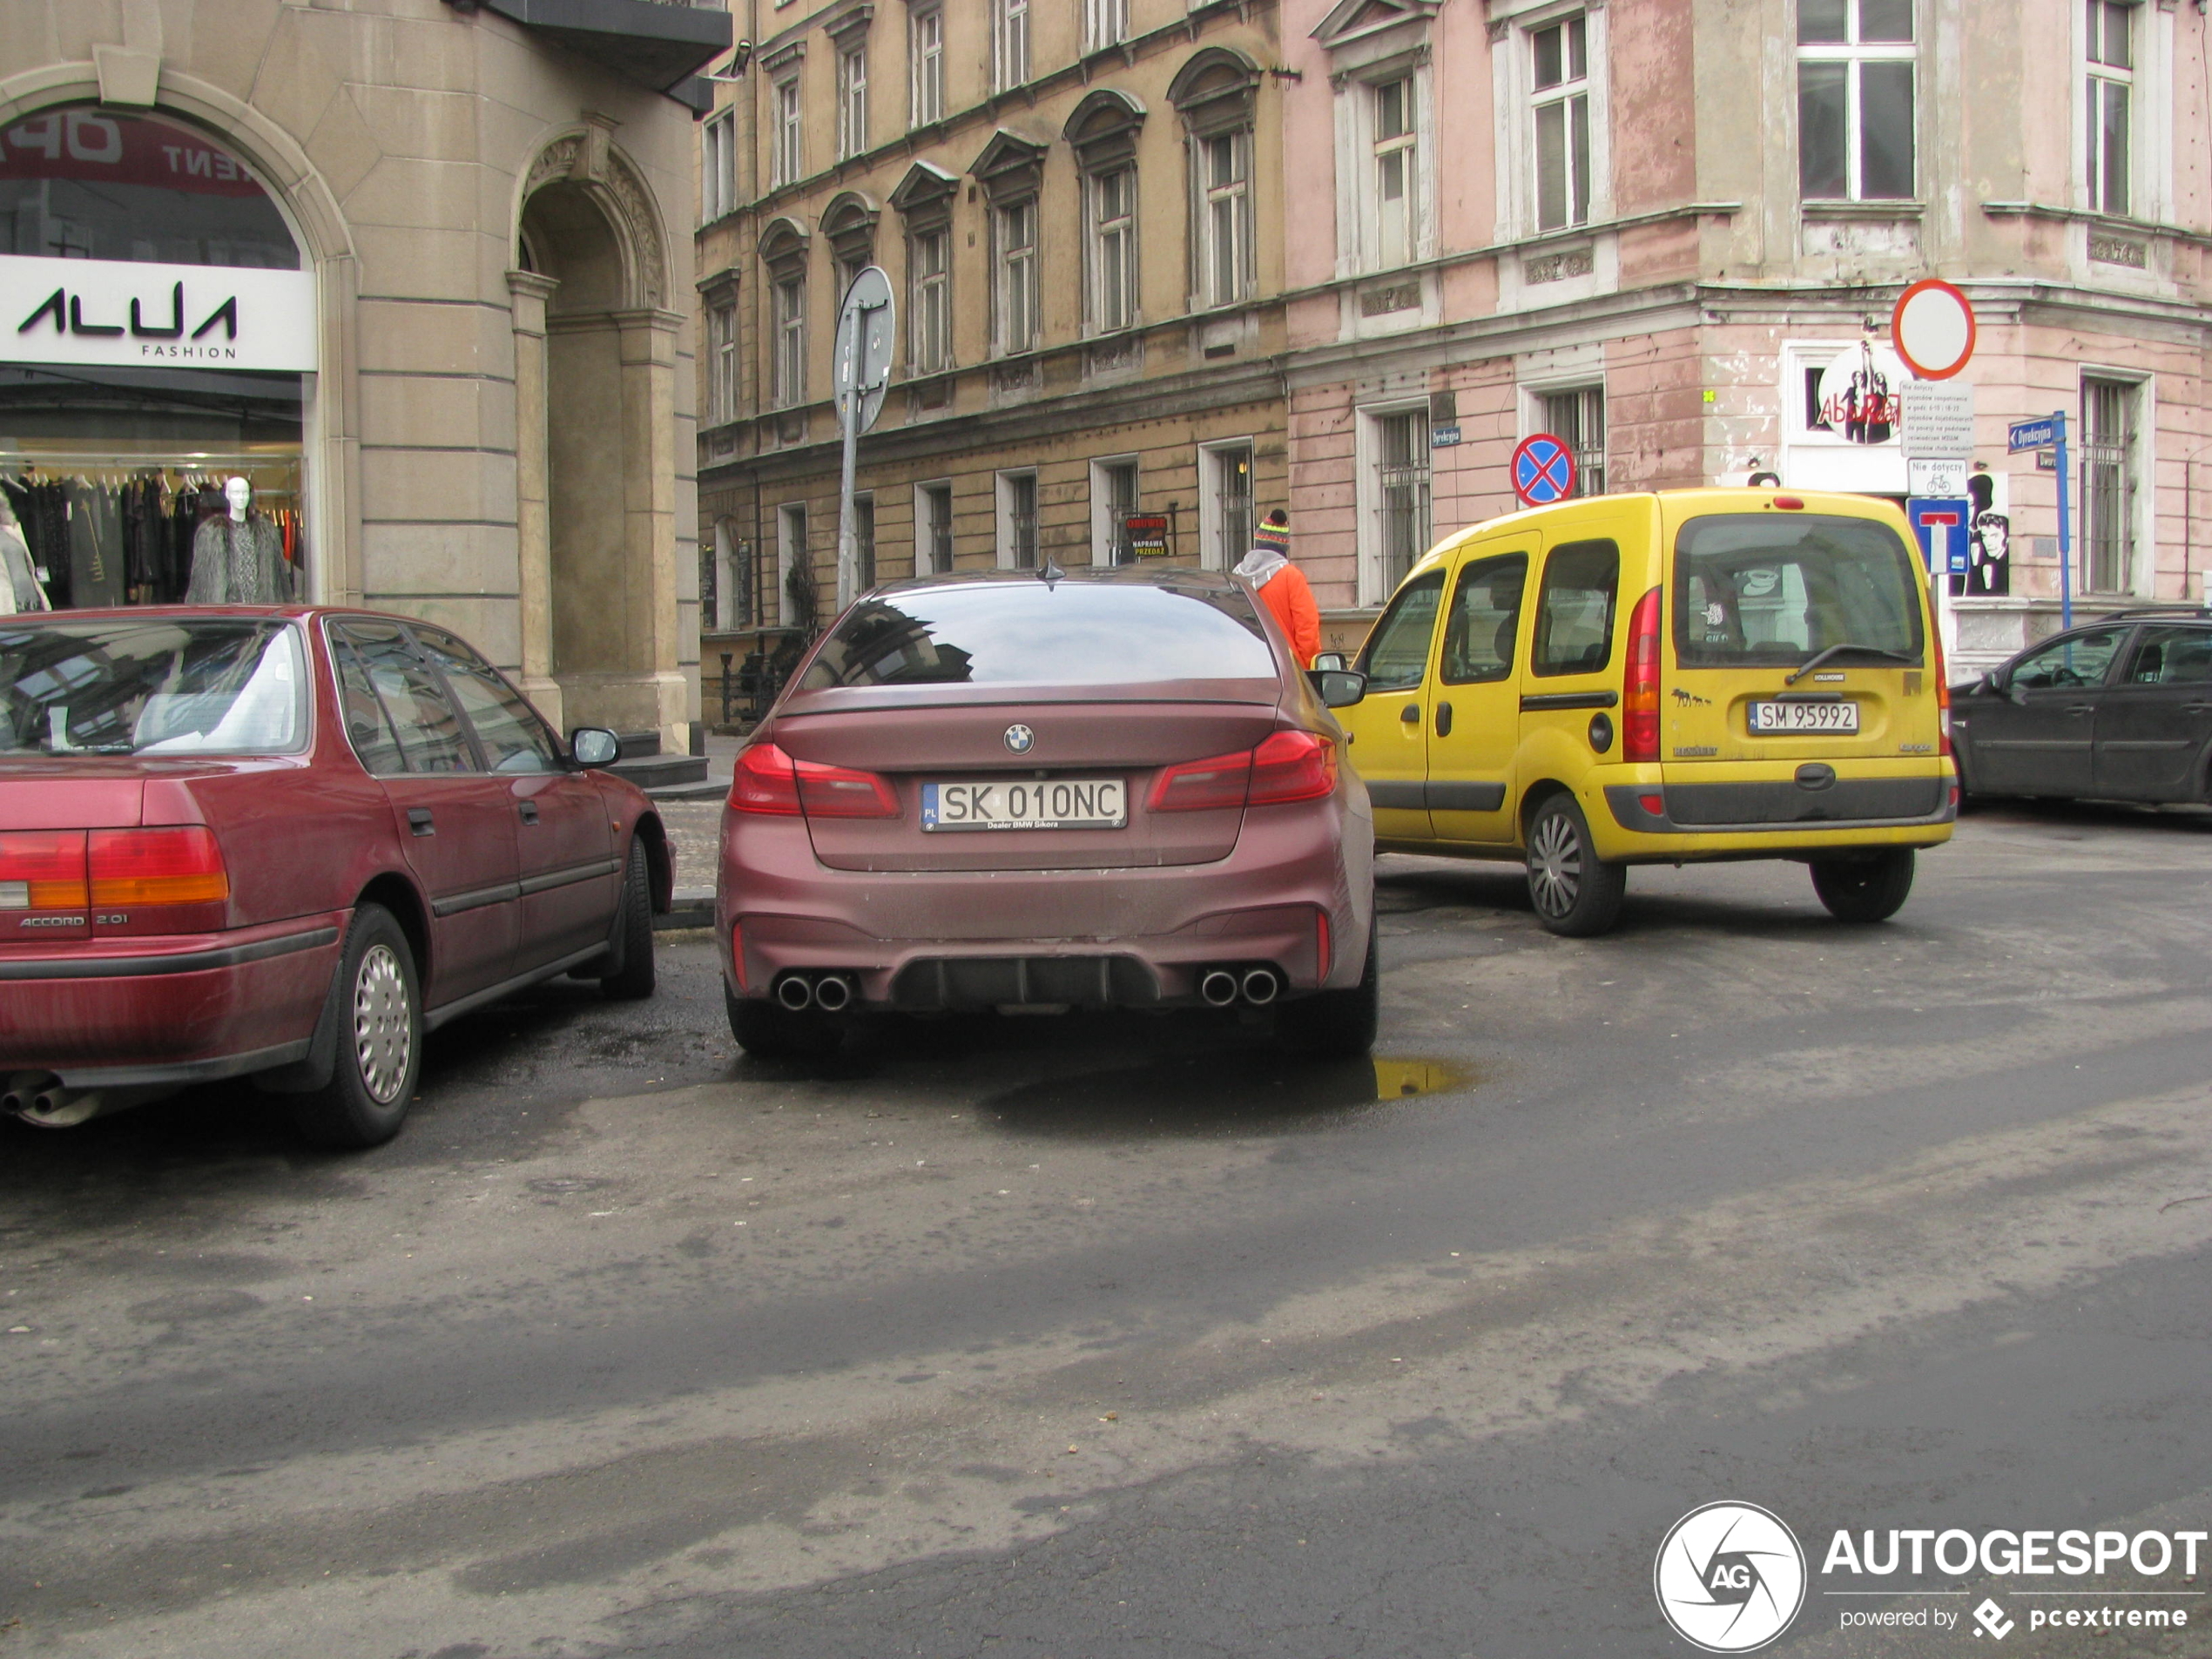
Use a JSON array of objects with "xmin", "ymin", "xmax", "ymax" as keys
[{"xmin": 0, "ymin": 617, "xmax": 307, "ymax": 754}]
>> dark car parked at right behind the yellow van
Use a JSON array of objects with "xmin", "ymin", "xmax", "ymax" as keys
[{"xmin": 1951, "ymin": 610, "xmax": 2212, "ymax": 800}]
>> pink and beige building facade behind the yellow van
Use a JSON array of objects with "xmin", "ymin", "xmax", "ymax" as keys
[{"xmin": 1283, "ymin": 0, "xmax": 2212, "ymax": 666}]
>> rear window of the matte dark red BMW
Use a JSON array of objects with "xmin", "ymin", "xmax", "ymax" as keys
[{"xmin": 799, "ymin": 579, "xmax": 1277, "ymax": 690}]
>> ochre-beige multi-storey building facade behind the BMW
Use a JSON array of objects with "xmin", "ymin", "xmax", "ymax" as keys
[{"xmin": 697, "ymin": 0, "xmax": 1287, "ymax": 701}]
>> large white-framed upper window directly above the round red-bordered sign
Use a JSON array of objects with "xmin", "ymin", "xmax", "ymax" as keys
[{"xmin": 1798, "ymin": 0, "xmax": 1918, "ymax": 201}]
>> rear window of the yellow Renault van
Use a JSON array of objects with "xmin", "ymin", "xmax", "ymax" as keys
[{"xmin": 1675, "ymin": 513, "xmax": 1922, "ymax": 668}]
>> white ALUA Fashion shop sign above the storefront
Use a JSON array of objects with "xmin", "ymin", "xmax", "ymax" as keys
[{"xmin": 0, "ymin": 254, "xmax": 316, "ymax": 374}]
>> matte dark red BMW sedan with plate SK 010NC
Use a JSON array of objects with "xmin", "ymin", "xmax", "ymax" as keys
[{"xmin": 717, "ymin": 569, "xmax": 1376, "ymax": 1055}]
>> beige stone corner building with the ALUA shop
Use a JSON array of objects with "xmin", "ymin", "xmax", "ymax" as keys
[{"xmin": 0, "ymin": 0, "xmax": 732, "ymax": 752}]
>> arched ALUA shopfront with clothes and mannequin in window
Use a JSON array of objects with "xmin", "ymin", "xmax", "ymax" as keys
[{"xmin": 0, "ymin": 106, "xmax": 323, "ymax": 609}]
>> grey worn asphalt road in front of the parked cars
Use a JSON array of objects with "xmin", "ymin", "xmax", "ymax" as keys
[{"xmin": 0, "ymin": 807, "xmax": 2212, "ymax": 1659}]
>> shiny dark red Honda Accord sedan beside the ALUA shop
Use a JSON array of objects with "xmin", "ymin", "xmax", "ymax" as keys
[{"xmin": 0, "ymin": 606, "xmax": 672, "ymax": 1146}]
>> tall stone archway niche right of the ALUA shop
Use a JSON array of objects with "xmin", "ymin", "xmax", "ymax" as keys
[{"xmin": 507, "ymin": 122, "xmax": 690, "ymax": 754}]
